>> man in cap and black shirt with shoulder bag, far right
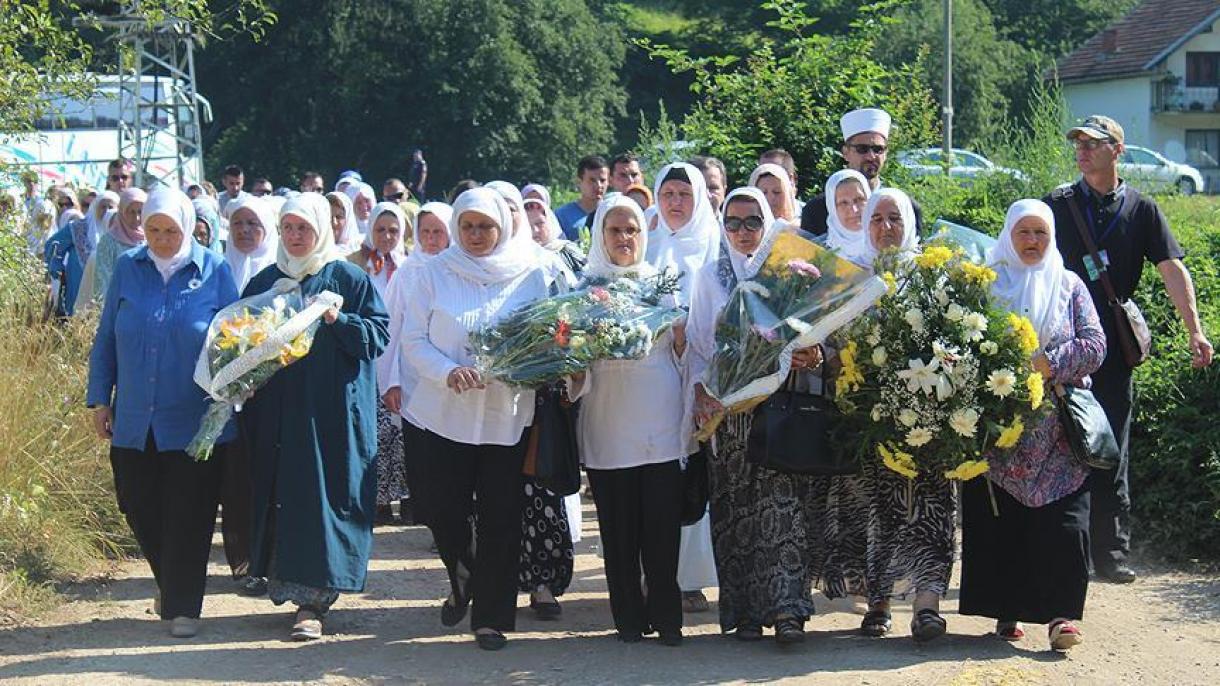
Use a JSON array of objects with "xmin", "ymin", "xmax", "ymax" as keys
[{"xmin": 1044, "ymin": 115, "xmax": 1211, "ymax": 583}]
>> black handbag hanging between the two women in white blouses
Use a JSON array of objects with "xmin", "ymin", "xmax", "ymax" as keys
[{"xmin": 521, "ymin": 386, "xmax": 581, "ymax": 497}]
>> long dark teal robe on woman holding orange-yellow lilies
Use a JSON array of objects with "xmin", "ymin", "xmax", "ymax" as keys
[{"xmin": 239, "ymin": 260, "xmax": 389, "ymax": 602}]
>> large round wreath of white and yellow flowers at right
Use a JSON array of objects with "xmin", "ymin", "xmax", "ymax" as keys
[{"xmin": 837, "ymin": 243, "xmax": 1043, "ymax": 480}]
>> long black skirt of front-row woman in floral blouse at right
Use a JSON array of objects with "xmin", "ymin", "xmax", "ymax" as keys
[{"xmin": 959, "ymin": 477, "xmax": 1089, "ymax": 624}]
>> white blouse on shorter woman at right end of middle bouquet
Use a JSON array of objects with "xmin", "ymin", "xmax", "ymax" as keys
[{"xmin": 576, "ymin": 332, "xmax": 697, "ymax": 469}]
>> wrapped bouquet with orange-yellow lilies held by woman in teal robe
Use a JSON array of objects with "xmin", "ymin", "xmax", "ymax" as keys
[{"xmin": 187, "ymin": 278, "xmax": 343, "ymax": 460}]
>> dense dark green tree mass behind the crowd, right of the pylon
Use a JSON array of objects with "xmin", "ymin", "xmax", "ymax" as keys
[{"xmin": 200, "ymin": 0, "xmax": 625, "ymax": 190}]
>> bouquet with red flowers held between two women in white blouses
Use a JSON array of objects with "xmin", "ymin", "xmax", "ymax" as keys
[{"xmin": 470, "ymin": 272, "xmax": 683, "ymax": 388}]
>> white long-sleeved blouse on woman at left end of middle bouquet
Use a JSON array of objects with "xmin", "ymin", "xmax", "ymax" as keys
[{"xmin": 398, "ymin": 260, "xmax": 548, "ymax": 446}]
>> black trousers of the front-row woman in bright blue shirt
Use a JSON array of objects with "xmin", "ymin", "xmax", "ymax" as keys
[{"xmin": 110, "ymin": 432, "xmax": 222, "ymax": 619}]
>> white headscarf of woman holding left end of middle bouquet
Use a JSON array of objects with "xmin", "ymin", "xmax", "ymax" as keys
[{"xmin": 437, "ymin": 187, "xmax": 534, "ymax": 286}]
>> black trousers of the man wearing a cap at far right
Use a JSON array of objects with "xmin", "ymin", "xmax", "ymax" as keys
[{"xmin": 1088, "ymin": 354, "xmax": 1132, "ymax": 570}]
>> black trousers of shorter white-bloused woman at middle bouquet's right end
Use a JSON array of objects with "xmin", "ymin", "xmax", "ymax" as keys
[{"xmin": 587, "ymin": 460, "xmax": 682, "ymax": 634}]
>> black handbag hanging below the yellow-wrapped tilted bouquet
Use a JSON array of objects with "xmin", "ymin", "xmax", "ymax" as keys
[{"xmin": 745, "ymin": 360, "xmax": 860, "ymax": 476}]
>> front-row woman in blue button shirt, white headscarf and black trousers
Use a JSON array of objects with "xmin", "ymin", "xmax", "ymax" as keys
[{"xmin": 85, "ymin": 188, "xmax": 237, "ymax": 637}]
